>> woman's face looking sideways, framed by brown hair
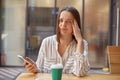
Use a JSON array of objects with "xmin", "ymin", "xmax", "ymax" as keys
[{"xmin": 59, "ymin": 11, "xmax": 74, "ymax": 35}]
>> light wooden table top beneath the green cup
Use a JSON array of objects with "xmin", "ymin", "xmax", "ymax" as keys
[{"xmin": 16, "ymin": 73, "xmax": 120, "ymax": 80}]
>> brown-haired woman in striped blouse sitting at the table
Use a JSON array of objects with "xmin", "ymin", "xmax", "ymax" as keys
[{"xmin": 25, "ymin": 6, "xmax": 89, "ymax": 76}]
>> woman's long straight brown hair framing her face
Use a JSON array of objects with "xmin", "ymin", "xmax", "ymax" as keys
[{"xmin": 56, "ymin": 6, "xmax": 81, "ymax": 42}]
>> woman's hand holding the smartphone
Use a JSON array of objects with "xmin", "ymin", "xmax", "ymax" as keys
[{"xmin": 24, "ymin": 57, "xmax": 37, "ymax": 73}]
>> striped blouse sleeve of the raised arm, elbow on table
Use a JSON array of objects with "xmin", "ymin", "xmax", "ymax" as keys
[{"xmin": 73, "ymin": 40, "xmax": 90, "ymax": 76}]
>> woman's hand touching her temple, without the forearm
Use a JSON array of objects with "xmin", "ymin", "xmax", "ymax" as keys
[{"xmin": 72, "ymin": 20, "xmax": 82, "ymax": 42}]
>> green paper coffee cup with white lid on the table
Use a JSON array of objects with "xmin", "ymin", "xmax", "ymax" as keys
[{"xmin": 51, "ymin": 64, "xmax": 63, "ymax": 80}]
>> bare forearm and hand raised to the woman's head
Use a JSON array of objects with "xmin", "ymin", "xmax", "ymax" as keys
[{"xmin": 72, "ymin": 20, "xmax": 84, "ymax": 53}]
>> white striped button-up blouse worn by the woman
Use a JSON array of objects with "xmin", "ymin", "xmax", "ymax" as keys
[{"xmin": 36, "ymin": 35, "xmax": 89, "ymax": 76}]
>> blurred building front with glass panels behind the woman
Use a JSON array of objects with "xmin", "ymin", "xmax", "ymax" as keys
[{"xmin": 0, "ymin": 0, "xmax": 120, "ymax": 68}]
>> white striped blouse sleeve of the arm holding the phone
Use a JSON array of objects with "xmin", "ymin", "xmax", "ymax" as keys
[{"xmin": 36, "ymin": 40, "xmax": 45, "ymax": 72}]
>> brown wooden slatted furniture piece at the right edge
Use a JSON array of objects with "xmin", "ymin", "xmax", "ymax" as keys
[{"xmin": 107, "ymin": 46, "xmax": 120, "ymax": 74}]
